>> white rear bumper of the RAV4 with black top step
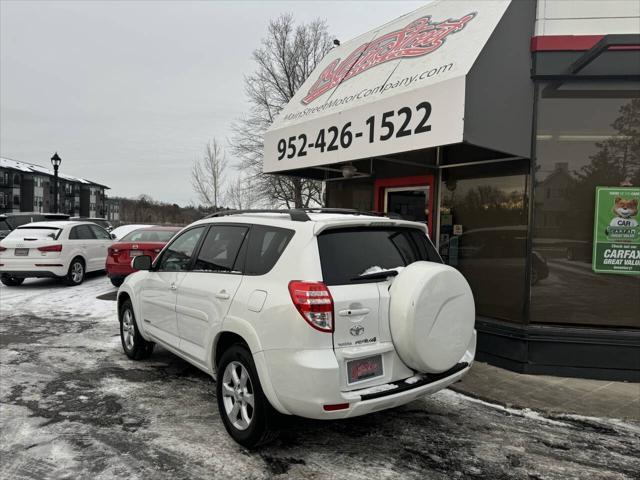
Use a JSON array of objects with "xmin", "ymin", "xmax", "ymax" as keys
[{"xmin": 255, "ymin": 335, "xmax": 476, "ymax": 420}]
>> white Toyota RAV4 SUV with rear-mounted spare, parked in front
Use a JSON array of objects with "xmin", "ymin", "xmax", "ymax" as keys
[{"xmin": 118, "ymin": 209, "xmax": 476, "ymax": 447}]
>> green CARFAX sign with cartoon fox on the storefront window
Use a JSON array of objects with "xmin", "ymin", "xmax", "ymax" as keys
[{"xmin": 592, "ymin": 187, "xmax": 640, "ymax": 275}]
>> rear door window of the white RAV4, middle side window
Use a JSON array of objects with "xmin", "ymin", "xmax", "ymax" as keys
[{"xmin": 193, "ymin": 225, "xmax": 249, "ymax": 272}]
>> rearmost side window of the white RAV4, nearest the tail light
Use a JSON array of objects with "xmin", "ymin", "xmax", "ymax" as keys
[{"xmin": 244, "ymin": 225, "xmax": 294, "ymax": 275}]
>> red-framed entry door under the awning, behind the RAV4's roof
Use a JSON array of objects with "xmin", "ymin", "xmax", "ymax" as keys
[{"xmin": 374, "ymin": 175, "xmax": 434, "ymax": 238}]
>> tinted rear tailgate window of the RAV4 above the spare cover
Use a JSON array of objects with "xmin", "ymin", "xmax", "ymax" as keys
[{"xmin": 318, "ymin": 227, "xmax": 442, "ymax": 285}]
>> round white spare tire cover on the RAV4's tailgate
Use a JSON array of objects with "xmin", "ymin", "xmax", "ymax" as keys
[{"xmin": 389, "ymin": 262, "xmax": 475, "ymax": 373}]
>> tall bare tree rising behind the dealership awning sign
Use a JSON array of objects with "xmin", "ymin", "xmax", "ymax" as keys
[{"xmin": 231, "ymin": 15, "xmax": 332, "ymax": 208}]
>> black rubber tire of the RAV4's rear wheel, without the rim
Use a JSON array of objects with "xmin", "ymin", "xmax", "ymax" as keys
[{"xmin": 216, "ymin": 344, "xmax": 278, "ymax": 449}]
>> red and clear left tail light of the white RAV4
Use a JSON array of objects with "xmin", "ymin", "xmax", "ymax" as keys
[{"xmin": 289, "ymin": 280, "xmax": 333, "ymax": 333}]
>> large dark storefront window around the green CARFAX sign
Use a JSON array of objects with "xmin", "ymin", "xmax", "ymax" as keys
[{"xmin": 530, "ymin": 85, "xmax": 640, "ymax": 328}]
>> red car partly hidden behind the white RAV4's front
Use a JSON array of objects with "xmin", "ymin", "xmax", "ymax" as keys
[{"xmin": 105, "ymin": 227, "xmax": 181, "ymax": 287}]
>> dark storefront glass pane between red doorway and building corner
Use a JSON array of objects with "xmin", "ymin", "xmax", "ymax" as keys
[{"xmin": 440, "ymin": 161, "xmax": 529, "ymax": 322}]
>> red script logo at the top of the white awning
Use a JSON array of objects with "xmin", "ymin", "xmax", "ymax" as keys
[{"xmin": 302, "ymin": 12, "xmax": 476, "ymax": 105}]
